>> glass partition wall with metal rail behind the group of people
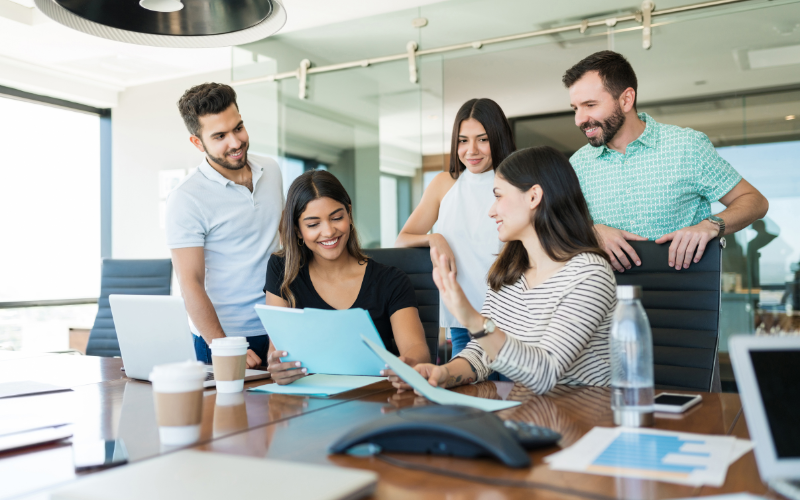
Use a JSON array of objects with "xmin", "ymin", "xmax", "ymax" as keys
[{"xmin": 233, "ymin": 0, "xmax": 800, "ymax": 364}]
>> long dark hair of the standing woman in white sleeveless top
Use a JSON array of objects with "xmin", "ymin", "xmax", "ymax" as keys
[{"xmin": 450, "ymin": 99, "xmax": 517, "ymax": 179}]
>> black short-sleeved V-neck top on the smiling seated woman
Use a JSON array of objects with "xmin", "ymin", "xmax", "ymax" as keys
[{"xmin": 264, "ymin": 255, "xmax": 417, "ymax": 355}]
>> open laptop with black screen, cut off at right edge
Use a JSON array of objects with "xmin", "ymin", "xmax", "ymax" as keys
[{"xmin": 729, "ymin": 335, "xmax": 800, "ymax": 500}]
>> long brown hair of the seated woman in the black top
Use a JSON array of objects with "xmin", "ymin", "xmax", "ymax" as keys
[{"xmin": 275, "ymin": 170, "xmax": 367, "ymax": 307}]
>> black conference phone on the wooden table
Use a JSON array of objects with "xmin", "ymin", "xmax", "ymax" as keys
[{"xmin": 330, "ymin": 405, "xmax": 561, "ymax": 467}]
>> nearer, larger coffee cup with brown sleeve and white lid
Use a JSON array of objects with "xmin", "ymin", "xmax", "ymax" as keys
[{"xmin": 150, "ymin": 361, "xmax": 206, "ymax": 445}]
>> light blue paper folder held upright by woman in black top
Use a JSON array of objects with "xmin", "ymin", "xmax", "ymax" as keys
[{"xmin": 256, "ymin": 304, "xmax": 385, "ymax": 376}]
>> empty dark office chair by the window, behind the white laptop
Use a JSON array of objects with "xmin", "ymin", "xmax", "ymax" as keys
[{"xmin": 86, "ymin": 259, "xmax": 172, "ymax": 357}]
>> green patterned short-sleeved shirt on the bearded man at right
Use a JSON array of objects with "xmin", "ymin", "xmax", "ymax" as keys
[{"xmin": 570, "ymin": 113, "xmax": 742, "ymax": 240}]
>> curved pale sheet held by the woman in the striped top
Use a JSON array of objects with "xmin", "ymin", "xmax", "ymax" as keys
[{"xmin": 361, "ymin": 337, "xmax": 520, "ymax": 411}]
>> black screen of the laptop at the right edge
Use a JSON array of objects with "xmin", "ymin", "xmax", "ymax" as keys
[{"xmin": 750, "ymin": 350, "xmax": 800, "ymax": 458}]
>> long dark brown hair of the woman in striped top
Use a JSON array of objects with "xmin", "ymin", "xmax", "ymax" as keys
[{"xmin": 487, "ymin": 146, "xmax": 608, "ymax": 292}]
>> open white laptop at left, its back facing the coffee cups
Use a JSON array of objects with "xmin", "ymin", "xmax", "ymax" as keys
[{"xmin": 108, "ymin": 295, "xmax": 270, "ymax": 387}]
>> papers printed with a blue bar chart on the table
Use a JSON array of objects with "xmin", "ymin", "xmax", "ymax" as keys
[{"xmin": 545, "ymin": 427, "xmax": 753, "ymax": 486}]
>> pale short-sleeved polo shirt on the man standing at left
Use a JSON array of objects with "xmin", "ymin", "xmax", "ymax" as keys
[{"xmin": 166, "ymin": 154, "xmax": 283, "ymax": 337}]
